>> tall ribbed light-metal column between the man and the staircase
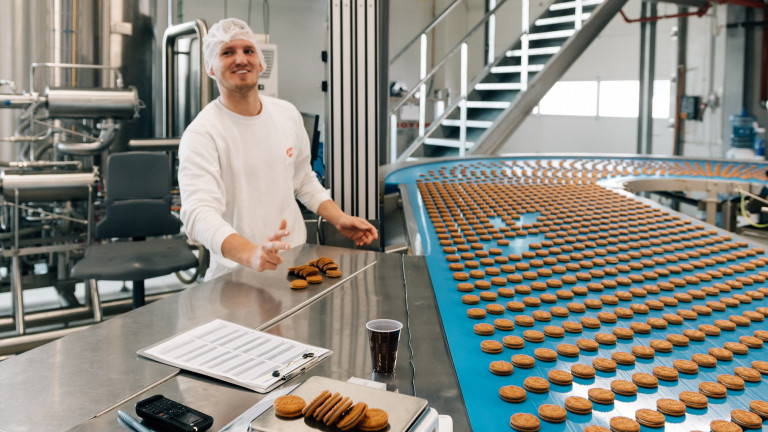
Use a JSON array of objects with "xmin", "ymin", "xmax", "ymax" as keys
[{"xmin": 326, "ymin": 0, "xmax": 388, "ymax": 219}]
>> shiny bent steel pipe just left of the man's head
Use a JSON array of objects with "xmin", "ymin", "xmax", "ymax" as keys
[{"xmin": 163, "ymin": 19, "xmax": 213, "ymax": 137}]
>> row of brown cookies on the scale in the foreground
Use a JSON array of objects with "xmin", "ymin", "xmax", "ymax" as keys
[{"xmin": 273, "ymin": 390, "xmax": 389, "ymax": 432}]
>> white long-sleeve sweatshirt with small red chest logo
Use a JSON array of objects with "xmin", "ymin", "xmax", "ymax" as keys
[{"xmin": 179, "ymin": 96, "xmax": 330, "ymax": 279}]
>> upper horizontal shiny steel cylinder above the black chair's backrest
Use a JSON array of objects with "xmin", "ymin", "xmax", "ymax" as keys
[{"xmin": 44, "ymin": 87, "xmax": 141, "ymax": 119}]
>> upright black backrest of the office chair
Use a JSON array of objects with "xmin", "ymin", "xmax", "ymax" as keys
[{"xmin": 96, "ymin": 152, "xmax": 181, "ymax": 239}]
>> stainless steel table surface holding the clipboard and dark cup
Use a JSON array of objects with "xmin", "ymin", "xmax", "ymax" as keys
[{"xmin": 0, "ymin": 245, "xmax": 469, "ymax": 431}]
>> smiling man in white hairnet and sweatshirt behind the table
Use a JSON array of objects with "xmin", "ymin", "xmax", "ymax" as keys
[{"xmin": 179, "ymin": 18, "xmax": 378, "ymax": 278}]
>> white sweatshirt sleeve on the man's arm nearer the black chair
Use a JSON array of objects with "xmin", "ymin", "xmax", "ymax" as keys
[{"xmin": 179, "ymin": 129, "xmax": 235, "ymax": 255}]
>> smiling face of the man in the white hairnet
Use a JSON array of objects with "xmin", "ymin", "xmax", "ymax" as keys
[{"xmin": 213, "ymin": 39, "xmax": 264, "ymax": 93}]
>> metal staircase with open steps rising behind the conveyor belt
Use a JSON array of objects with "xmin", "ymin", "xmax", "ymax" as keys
[{"xmin": 391, "ymin": 0, "xmax": 626, "ymax": 162}]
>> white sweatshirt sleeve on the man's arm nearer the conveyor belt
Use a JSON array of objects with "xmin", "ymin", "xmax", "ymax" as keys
[{"xmin": 293, "ymin": 109, "xmax": 331, "ymax": 213}]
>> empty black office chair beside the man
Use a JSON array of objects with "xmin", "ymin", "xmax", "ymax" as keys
[{"xmin": 72, "ymin": 152, "xmax": 197, "ymax": 308}]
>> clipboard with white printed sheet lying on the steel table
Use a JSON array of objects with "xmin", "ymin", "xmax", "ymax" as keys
[{"xmin": 137, "ymin": 319, "xmax": 333, "ymax": 393}]
